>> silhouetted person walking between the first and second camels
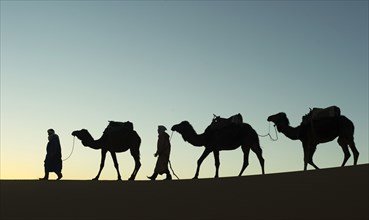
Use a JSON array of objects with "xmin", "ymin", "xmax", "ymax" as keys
[{"xmin": 147, "ymin": 125, "xmax": 172, "ymax": 180}]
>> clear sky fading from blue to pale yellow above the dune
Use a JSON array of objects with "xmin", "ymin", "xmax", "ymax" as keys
[{"xmin": 0, "ymin": 0, "xmax": 369, "ymax": 180}]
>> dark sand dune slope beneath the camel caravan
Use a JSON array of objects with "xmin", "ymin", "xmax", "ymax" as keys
[{"xmin": 0, "ymin": 164, "xmax": 369, "ymax": 220}]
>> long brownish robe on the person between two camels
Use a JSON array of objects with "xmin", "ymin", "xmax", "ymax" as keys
[{"xmin": 154, "ymin": 132, "xmax": 171, "ymax": 174}]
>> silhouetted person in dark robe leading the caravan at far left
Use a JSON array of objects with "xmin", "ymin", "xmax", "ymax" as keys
[{"xmin": 40, "ymin": 129, "xmax": 63, "ymax": 180}]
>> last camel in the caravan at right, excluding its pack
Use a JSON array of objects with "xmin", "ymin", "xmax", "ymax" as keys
[{"xmin": 268, "ymin": 112, "xmax": 359, "ymax": 170}]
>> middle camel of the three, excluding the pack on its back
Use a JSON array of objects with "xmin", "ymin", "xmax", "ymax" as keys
[{"xmin": 172, "ymin": 121, "xmax": 264, "ymax": 179}]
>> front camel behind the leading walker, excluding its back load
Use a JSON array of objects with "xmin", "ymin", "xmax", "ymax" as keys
[{"xmin": 72, "ymin": 122, "xmax": 141, "ymax": 180}]
